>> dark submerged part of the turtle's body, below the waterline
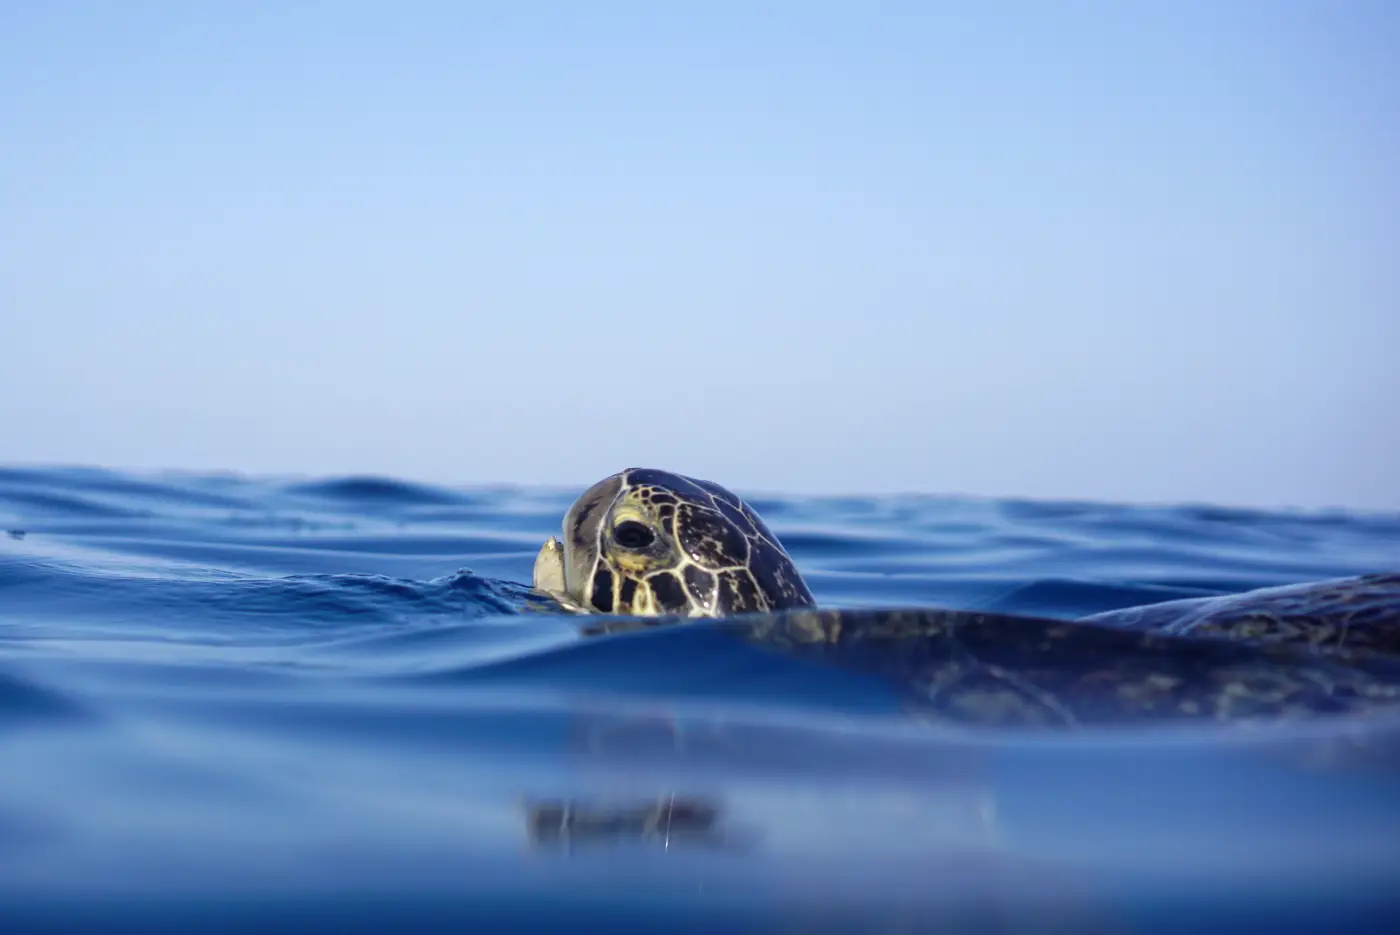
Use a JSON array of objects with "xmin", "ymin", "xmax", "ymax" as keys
[{"xmin": 582, "ymin": 609, "xmax": 1400, "ymax": 728}]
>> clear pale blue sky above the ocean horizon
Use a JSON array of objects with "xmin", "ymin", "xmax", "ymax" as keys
[{"xmin": 0, "ymin": 0, "xmax": 1400, "ymax": 508}]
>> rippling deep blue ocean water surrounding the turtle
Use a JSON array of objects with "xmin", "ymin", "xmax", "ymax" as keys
[{"xmin": 0, "ymin": 469, "xmax": 1400, "ymax": 935}]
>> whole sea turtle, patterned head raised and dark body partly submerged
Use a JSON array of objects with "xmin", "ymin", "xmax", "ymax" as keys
[{"xmin": 533, "ymin": 468, "xmax": 1400, "ymax": 726}]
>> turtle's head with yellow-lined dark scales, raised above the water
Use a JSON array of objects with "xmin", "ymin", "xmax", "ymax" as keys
[{"xmin": 535, "ymin": 468, "xmax": 816, "ymax": 617}]
